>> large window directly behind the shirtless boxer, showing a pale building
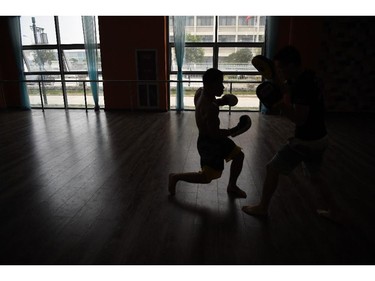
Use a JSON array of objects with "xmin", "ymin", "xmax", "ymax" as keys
[{"xmin": 169, "ymin": 16, "xmax": 266, "ymax": 111}]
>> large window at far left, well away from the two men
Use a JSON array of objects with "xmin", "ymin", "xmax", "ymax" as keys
[{"xmin": 21, "ymin": 16, "xmax": 104, "ymax": 108}]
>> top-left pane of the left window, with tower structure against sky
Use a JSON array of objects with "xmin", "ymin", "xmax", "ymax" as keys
[{"xmin": 20, "ymin": 16, "xmax": 57, "ymax": 45}]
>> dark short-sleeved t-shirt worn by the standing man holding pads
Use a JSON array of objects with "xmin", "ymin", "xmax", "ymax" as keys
[{"xmin": 289, "ymin": 70, "xmax": 327, "ymax": 140}]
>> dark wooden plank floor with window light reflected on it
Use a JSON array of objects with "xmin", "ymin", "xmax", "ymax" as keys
[{"xmin": 0, "ymin": 110, "xmax": 375, "ymax": 265}]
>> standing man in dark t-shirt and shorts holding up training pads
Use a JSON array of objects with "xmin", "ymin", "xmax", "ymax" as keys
[{"xmin": 242, "ymin": 46, "xmax": 332, "ymax": 218}]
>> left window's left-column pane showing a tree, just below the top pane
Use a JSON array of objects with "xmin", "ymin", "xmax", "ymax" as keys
[{"xmin": 23, "ymin": 49, "xmax": 60, "ymax": 72}]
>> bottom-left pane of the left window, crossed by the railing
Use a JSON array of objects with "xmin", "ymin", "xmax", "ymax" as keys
[{"xmin": 26, "ymin": 75, "xmax": 64, "ymax": 108}]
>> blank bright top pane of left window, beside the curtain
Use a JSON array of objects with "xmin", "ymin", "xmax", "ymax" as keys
[{"xmin": 59, "ymin": 16, "xmax": 84, "ymax": 44}]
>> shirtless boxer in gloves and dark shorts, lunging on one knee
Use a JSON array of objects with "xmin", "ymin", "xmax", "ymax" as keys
[{"xmin": 168, "ymin": 68, "xmax": 251, "ymax": 198}]
